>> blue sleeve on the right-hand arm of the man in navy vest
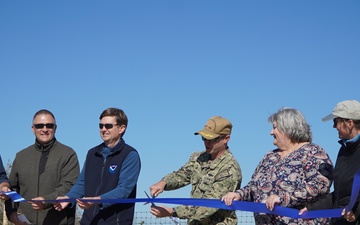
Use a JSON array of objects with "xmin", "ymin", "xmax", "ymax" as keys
[{"xmin": 100, "ymin": 151, "xmax": 141, "ymax": 208}]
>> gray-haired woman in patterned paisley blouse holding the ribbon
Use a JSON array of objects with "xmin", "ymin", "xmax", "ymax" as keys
[{"xmin": 222, "ymin": 108, "xmax": 333, "ymax": 225}]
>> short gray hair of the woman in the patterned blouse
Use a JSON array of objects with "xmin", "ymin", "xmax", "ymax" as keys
[{"xmin": 268, "ymin": 108, "xmax": 312, "ymax": 143}]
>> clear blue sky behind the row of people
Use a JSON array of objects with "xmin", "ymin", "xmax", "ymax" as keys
[{"xmin": 0, "ymin": 0, "xmax": 360, "ymax": 214}]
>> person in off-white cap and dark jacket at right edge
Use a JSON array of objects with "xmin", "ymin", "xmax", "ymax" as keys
[{"xmin": 300, "ymin": 100, "xmax": 360, "ymax": 225}]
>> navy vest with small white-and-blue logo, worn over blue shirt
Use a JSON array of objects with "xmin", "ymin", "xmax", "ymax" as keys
[{"xmin": 80, "ymin": 139, "xmax": 136, "ymax": 225}]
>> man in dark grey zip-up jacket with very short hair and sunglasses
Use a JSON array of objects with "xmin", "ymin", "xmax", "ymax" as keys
[{"xmin": 6, "ymin": 109, "xmax": 80, "ymax": 225}]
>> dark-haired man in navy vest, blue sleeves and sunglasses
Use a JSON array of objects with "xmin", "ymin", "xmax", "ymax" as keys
[{"xmin": 55, "ymin": 108, "xmax": 141, "ymax": 225}]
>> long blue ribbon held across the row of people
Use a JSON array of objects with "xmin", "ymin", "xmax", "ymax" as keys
[{"xmin": 4, "ymin": 170, "xmax": 360, "ymax": 219}]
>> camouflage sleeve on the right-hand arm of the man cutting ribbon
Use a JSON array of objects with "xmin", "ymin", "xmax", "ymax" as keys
[{"xmin": 175, "ymin": 153, "xmax": 242, "ymax": 221}]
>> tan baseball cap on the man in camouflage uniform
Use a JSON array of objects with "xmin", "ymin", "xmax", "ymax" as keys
[{"xmin": 194, "ymin": 116, "xmax": 232, "ymax": 140}]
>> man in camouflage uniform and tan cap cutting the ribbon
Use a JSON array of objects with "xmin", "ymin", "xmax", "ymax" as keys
[{"xmin": 150, "ymin": 116, "xmax": 242, "ymax": 225}]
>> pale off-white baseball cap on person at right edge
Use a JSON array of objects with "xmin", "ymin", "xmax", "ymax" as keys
[{"xmin": 322, "ymin": 100, "xmax": 360, "ymax": 121}]
